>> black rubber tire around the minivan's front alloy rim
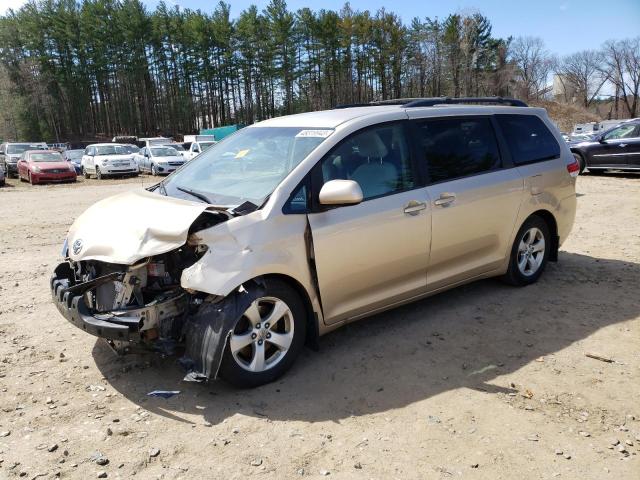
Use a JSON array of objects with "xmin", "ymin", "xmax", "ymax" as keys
[{"xmin": 220, "ymin": 279, "xmax": 307, "ymax": 388}]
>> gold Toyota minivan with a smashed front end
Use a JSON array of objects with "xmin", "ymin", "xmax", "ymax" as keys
[{"xmin": 51, "ymin": 98, "xmax": 578, "ymax": 387}]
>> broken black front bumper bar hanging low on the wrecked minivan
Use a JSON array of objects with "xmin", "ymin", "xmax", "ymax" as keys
[{"xmin": 51, "ymin": 263, "xmax": 140, "ymax": 342}]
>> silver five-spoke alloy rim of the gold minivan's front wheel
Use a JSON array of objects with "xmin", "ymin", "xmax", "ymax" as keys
[{"xmin": 229, "ymin": 297, "xmax": 294, "ymax": 373}]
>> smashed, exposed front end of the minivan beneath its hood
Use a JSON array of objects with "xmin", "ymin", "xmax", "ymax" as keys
[{"xmin": 51, "ymin": 211, "xmax": 261, "ymax": 381}]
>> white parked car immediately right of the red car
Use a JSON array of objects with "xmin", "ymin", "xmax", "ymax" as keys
[{"xmin": 82, "ymin": 143, "xmax": 138, "ymax": 180}]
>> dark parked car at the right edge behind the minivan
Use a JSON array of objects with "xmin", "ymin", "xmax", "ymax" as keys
[{"xmin": 569, "ymin": 118, "xmax": 640, "ymax": 173}]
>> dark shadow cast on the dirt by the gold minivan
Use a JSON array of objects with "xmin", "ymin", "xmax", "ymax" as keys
[{"xmin": 93, "ymin": 252, "xmax": 640, "ymax": 424}]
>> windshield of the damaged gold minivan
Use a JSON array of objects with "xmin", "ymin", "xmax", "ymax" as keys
[{"xmin": 165, "ymin": 127, "xmax": 333, "ymax": 206}]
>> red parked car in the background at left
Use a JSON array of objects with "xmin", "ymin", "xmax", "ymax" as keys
[{"xmin": 18, "ymin": 150, "xmax": 76, "ymax": 184}]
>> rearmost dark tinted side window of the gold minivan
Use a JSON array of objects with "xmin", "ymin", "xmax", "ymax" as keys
[{"xmin": 496, "ymin": 115, "xmax": 560, "ymax": 165}]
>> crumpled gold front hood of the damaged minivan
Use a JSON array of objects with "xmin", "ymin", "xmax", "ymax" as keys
[{"xmin": 67, "ymin": 190, "xmax": 209, "ymax": 265}]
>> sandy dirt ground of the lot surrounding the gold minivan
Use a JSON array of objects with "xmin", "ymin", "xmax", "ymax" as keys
[{"xmin": 0, "ymin": 171, "xmax": 640, "ymax": 480}]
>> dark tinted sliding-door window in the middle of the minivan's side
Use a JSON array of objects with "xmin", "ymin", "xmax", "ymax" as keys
[{"xmin": 415, "ymin": 118, "xmax": 501, "ymax": 183}]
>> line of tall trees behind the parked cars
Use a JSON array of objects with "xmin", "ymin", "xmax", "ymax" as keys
[{"xmin": 0, "ymin": 0, "xmax": 640, "ymax": 140}]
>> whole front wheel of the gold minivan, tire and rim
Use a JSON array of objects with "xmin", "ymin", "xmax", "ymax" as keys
[{"xmin": 220, "ymin": 280, "xmax": 306, "ymax": 388}]
